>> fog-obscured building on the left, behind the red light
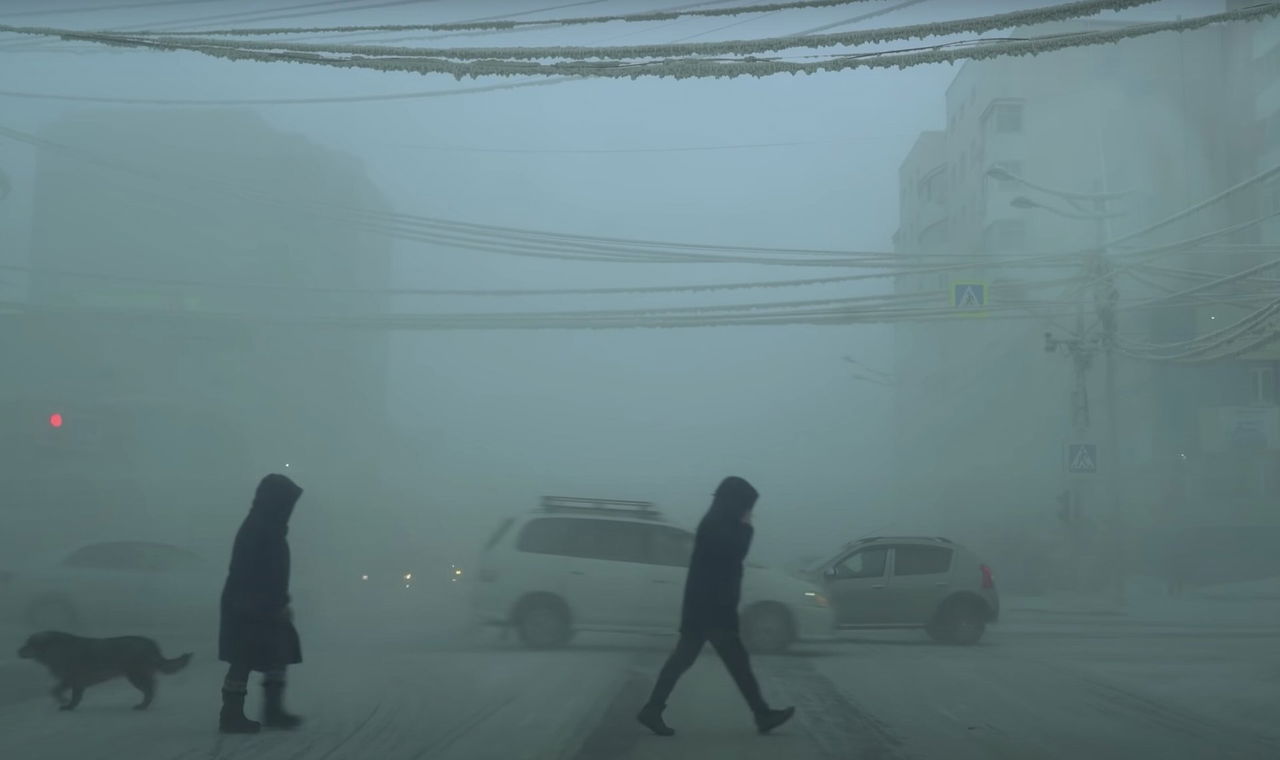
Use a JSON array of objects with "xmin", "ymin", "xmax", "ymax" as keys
[{"xmin": 0, "ymin": 110, "xmax": 390, "ymax": 552}]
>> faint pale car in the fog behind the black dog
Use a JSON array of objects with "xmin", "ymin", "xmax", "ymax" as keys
[{"xmin": 4, "ymin": 541, "xmax": 225, "ymax": 635}]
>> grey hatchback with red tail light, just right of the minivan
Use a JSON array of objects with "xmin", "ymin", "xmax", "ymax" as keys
[{"xmin": 805, "ymin": 536, "xmax": 1000, "ymax": 645}]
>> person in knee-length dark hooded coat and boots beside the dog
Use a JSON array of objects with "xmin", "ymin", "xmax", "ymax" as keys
[{"xmin": 218, "ymin": 475, "xmax": 302, "ymax": 733}]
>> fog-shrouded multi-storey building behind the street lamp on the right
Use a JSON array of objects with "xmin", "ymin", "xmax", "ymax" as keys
[{"xmin": 896, "ymin": 22, "xmax": 1280, "ymax": 585}]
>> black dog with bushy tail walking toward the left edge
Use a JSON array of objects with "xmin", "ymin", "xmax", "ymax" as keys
[{"xmin": 18, "ymin": 631, "xmax": 192, "ymax": 710}]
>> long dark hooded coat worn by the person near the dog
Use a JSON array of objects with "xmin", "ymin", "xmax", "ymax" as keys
[{"xmin": 218, "ymin": 475, "xmax": 302, "ymax": 670}]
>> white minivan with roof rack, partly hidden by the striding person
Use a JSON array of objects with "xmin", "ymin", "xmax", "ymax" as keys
[{"xmin": 472, "ymin": 498, "xmax": 836, "ymax": 653}]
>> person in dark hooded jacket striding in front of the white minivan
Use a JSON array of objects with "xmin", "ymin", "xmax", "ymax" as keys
[{"xmin": 637, "ymin": 477, "xmax": 795, "ymax": 736}]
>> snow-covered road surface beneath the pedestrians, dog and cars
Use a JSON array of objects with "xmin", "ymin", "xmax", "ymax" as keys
[{"xmin": 0, "ymin": 600, "xmax": 1280, "ymax": 760}]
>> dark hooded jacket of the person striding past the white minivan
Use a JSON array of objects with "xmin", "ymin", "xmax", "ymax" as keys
[{"xmin": 680, "ymin": 477, "xmax": 759, "ymax": 635}]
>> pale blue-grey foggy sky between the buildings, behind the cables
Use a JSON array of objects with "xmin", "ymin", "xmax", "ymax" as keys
[{"xmin": 0, "ymin": 0, "xmax": 1221, "ymax": 555}]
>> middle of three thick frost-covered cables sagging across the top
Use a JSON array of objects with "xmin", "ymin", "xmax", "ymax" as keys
[{"xmin": 55, "ymin": 0, "xmax": 1160, "ymax": 63}]
